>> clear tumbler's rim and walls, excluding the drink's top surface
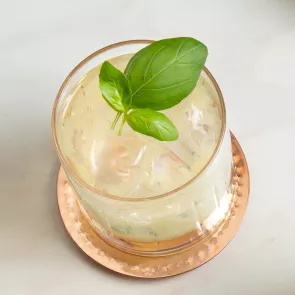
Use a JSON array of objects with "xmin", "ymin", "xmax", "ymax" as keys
[{"xmin": 52, "ymin": 40, "xmax": 233, "ymax": 255}]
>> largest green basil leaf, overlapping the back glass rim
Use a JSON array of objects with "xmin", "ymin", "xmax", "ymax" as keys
[{"xmin": 125, "ymin": 37, "xmax": 208, "ymax": 110}]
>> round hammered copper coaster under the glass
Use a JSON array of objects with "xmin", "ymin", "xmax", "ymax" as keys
[{"xmin": 57, "ymin": 134, "xmax": 250, "ymax": 278}]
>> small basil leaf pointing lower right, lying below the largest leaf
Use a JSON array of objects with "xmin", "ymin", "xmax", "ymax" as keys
[{"xmin": 126, "ymin": 109, "xmax": 178, "ymax": 141}]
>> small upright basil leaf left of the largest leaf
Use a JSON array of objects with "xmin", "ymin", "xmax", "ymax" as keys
[{"xmin": 99, "ymin": 61, "xmax": 132, "ymax": 113}]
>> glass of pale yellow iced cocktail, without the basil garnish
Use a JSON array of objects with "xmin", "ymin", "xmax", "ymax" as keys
[{"xmin": 52, "ymin": 40, "xmax": 232, "ymax": 255}]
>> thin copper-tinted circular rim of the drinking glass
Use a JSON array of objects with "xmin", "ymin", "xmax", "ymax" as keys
[{"xmin": 51, "ymin": 39, "xmax": 226, "ymax": 202}]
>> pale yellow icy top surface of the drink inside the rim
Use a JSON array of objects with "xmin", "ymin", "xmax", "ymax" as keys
[{"xmin": 57, "ymin": 54, "xmax": 222, "ymax": 198}]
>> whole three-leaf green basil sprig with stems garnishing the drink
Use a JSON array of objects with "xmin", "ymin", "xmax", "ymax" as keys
[{"xmin": 99, "ymin": 37, "xmax": 208, "ymax": 141}]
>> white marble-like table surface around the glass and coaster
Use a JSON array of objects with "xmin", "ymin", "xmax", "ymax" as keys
[{"xmin": 0, "ymin": 0, "xmax": 295, "ymax": 295}]
